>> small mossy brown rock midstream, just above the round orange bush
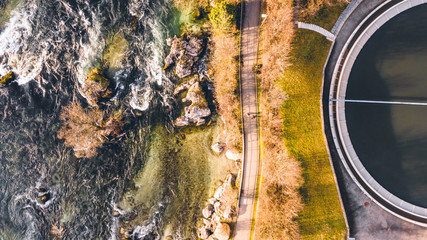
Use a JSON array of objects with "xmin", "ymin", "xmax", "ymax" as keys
[{"xmin": 83, "ymin": 68, "xmax": 113, "ymax": 105}]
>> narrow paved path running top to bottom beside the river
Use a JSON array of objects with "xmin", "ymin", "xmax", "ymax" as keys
[{"xmin": 234, "ymin": 0, "xmax": 261, "ymax": 240}]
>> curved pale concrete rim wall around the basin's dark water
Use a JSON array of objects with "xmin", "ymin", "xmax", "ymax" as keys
[{"xmin": 329, "ymin": 0, "xmax": 427, "ymax": 226}]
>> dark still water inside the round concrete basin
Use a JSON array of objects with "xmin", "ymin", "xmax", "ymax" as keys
[{"xmin": 346, "ymin": 5, "xmax": 427, "ymax": 207}]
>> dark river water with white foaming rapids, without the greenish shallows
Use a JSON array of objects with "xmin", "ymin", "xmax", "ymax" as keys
[{"xmin": 0, "ymin": 0, "xmax": 182, "ymax": 240}]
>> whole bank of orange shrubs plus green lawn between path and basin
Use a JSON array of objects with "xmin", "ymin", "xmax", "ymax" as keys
[{"xmin": 255, "ymin": 0, "xmax": 347, "ymax": 239}]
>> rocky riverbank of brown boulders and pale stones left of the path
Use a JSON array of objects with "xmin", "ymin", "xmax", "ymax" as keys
[{"xmin": 160, "ymin": 4, "xmax": 241, "ymax": 240}]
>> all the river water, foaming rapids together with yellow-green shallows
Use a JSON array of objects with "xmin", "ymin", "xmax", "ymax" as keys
[{"xmin": 0, "ymin": 0, "xmax": 231, "ymax": 239}]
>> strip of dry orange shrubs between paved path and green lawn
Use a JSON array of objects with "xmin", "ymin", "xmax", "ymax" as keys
[{"xmin": 255, "ymin": 0, "xmax": 302, "ymax": 239}]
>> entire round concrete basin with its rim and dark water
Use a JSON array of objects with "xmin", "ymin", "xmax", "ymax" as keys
[{"xmin": 329, "ymin": 0, "xmax": 427, "ymax": 225}]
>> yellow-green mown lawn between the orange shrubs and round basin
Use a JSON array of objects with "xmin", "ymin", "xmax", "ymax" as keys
[{"xmin": 281, "ymin": 2, "xmax": 346, "ymax": 239}]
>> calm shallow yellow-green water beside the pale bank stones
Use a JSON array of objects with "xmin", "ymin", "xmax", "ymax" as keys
[{"xmin": 118, "ymin": 121, "xmax": 237, "ymax": 239}]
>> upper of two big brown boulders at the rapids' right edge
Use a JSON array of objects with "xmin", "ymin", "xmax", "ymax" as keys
[{"xmin": 164, "ymin": 33, "xmax": 203, "ymax": 78}]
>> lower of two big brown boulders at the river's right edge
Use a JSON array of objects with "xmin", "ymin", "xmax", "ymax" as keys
[{"xmin": 175, "ymin": 82, "xmax": 211, "ymax": 126}]
